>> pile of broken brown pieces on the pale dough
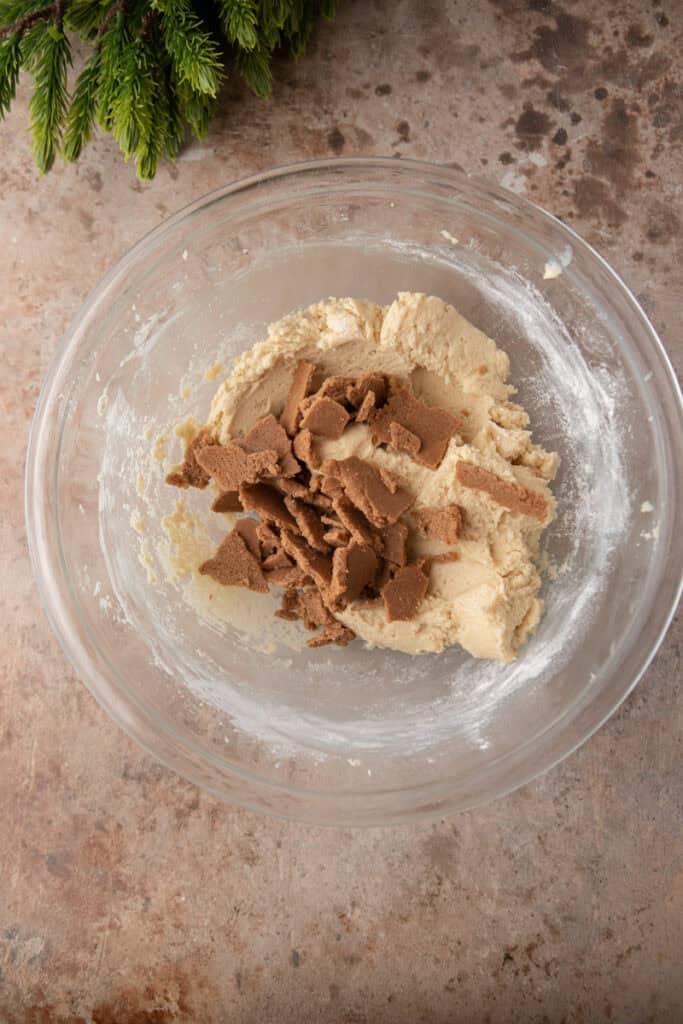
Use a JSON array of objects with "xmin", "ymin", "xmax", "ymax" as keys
[{"xmin": 167, "ymin": 361, "xmax": 464, "ymax": 647}]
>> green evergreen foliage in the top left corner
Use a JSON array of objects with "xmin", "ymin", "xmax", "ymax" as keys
[{"xmin": 0, "ymin": 0, "xmax": 334, "ymax": 178}]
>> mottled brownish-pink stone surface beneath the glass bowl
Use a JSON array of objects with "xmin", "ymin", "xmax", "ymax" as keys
[{"xmin": 0, "ymin": 0, "xmax": 683, "ymax": 1024}]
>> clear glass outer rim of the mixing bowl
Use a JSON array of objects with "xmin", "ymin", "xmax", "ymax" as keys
[{"xmin": 25, "ymin": 157, "xmax": 683, "ymax": 824}]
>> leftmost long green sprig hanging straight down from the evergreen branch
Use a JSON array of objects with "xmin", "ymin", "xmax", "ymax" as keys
[{"xmin": 29, "ymin": 18, "xmax": 71, "ymax": 174}]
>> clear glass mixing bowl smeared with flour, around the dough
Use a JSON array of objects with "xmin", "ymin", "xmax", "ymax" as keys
[{"xmin": 27, "ymin": 160, "xmax": 683, "ymax": 824}]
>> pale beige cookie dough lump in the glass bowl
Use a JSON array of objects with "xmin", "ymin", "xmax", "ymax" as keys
[{"xmin": 208, "ymin": 292, "xmax": 559, "ymax": 660}]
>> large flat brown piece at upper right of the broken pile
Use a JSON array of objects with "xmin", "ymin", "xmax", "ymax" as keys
[{"xmin": 371, "ymin": 382, "xmax": 458, "ymax": 469}]
